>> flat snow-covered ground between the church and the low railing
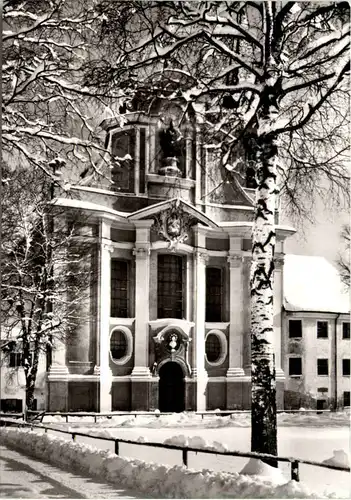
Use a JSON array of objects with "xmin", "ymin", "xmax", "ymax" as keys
[{"xmin": 2, "ymin": 412, "xmax": 350, "ymax": 498}]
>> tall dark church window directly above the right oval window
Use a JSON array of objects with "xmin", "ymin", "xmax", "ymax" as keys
[{"xmin": 206, "ymin": 267, "xmax": 223, "ymax": 322}]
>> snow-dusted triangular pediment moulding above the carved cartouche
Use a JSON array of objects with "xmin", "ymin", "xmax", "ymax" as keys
[{"xmin": 128, "ymin": 198, "xmax": 219, "ymax": 228}]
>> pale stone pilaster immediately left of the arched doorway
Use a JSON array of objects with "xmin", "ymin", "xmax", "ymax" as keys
[{"xmin": 132, "ymin": 220, "xmax": 153, "ymax": 410}]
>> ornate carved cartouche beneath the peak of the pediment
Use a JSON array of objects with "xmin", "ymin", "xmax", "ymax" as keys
[{"xmin": 152, "ymin": 200, "xmax": 195, "ymax": 252}]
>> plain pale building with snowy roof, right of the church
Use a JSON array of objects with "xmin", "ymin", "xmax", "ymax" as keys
[{"xmin": 282, "ymin": 255, "xmax": 351, "ymax": 409}]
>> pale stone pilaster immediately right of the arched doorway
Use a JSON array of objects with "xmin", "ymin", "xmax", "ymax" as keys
[{"xmin": 193, "ymin": 233, "xmax": 208, "ymax": 411}]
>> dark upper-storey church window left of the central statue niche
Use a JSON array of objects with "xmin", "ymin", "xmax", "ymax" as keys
[{"xmin": 111, "ymin": 129, "xmax": 136, "ymax": 193}]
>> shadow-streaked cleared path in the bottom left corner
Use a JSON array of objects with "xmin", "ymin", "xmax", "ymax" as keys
[{"xmin": 0, "ymin": 446, "xmax": 143, "ymax": 499}]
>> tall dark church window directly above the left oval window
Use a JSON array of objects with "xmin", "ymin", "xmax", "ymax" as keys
[{"xmin": 111, "ymin": 259, "xmax": 129, "ymax": 318}]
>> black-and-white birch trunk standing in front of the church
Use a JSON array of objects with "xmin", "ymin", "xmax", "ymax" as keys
[{"xmin": 250, "ymin": 126, "xmax": 277, "ymax": 467}]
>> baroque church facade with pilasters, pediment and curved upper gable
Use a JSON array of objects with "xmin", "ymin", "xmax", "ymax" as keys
[{"xmin": 46, "ymin": 74, "xmax": 294, "ymax": 412}]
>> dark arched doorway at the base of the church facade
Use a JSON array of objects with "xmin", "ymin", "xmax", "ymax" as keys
[{"xmin": 158, "ymin": 361, "xmax": 185, "ymax": 412}]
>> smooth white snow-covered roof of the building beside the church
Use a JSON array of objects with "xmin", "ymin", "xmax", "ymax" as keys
[{"xmin": 284, "ymin": 254, "xmax": 350, "ymax": 313}]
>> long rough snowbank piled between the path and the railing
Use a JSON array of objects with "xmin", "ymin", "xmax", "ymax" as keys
[{"xmin": 1, "ymin": 428, "xmax": 347, "ymax": 498}]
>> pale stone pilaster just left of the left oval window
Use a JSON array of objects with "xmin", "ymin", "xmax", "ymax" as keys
[{"xmin": 95, "ymin": 221, "xmax": 113, "ymax": 412}]
